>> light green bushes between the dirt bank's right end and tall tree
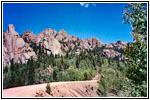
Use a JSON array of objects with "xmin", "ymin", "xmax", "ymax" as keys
[{"xmin": 98, "ymin": 68, "xmax": 128, "ymax": 96}]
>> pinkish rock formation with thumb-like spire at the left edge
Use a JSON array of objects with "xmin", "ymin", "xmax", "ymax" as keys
[{"xmin": 3, "ymin": 24, "xmax": 37, "ymax": 66}]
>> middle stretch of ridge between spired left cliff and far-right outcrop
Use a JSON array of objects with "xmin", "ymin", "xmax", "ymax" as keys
[{"xmin": 22, "ymin": 28, "xmax": 102, "ymax": 55}]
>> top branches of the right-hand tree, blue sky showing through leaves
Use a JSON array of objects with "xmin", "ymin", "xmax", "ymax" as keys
[{"xmin": 123, "ymin": 3, "xmax": 147, "ymax": 40}]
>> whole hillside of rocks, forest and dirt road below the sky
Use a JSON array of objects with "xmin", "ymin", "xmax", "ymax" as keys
[{"xmin": 3, "ymin": 24, "xmax": 128, "ymax": 97}]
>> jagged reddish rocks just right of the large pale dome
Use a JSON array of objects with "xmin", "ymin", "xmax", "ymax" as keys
[{"xmin": 56, "ymin": 30, "xmax": 102, "ymax": 53}]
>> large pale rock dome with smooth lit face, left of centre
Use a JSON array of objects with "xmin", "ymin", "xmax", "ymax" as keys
[{"xmin": 36, "ymin": 28, "xmax": 62, "ymax": 55}]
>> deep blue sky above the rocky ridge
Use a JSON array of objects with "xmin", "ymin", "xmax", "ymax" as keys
[{"xmin": 3, "ymin": 3, "xmax": 133, "ymax": 43}]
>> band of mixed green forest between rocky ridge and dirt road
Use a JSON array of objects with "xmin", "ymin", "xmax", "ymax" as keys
[{"xmin": 3, "ymin": 43, "xmax": 126, "ymax": 88}]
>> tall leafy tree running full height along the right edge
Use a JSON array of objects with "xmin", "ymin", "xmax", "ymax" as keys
[{"xmin": 123, "ymin": 3, "xmax": 147, "ymax": 97}]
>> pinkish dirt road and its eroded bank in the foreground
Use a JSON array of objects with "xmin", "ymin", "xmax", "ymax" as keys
[{"xmin": 3, "ymin": 80, "xmax": 98, "ymax": 97}]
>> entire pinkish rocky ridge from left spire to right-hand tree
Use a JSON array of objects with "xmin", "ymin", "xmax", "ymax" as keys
[{"xmin": 3, "ymin": 25, "xmax": 127, "ymax": 66}]
